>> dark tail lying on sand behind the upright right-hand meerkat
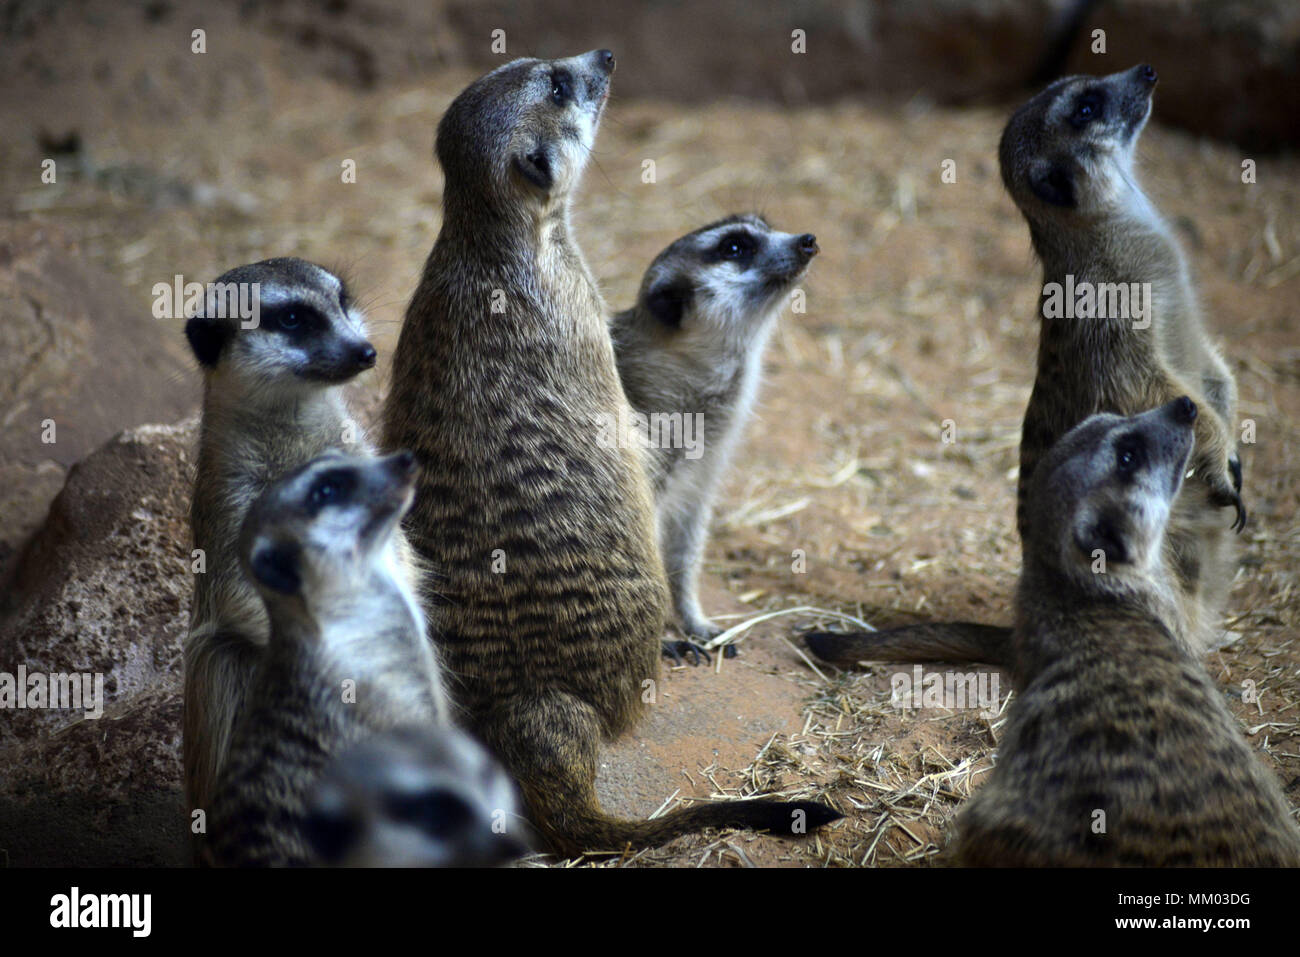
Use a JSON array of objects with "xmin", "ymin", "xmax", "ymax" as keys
[{"xmin": 803, "ymin": 622, "xmax": 1013, "ymax": 668}]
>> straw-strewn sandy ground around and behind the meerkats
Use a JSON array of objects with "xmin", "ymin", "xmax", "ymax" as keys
[{"xmin": 0, "ymin": 59, "xmax": 1300, "ymax": 866}]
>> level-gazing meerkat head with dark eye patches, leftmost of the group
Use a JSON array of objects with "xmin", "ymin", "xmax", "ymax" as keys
[{"xmin": 185, "ymin": 257, "xmax": 374, "ymax": 397}]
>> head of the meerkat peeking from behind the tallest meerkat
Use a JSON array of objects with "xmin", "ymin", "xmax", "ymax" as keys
[{"xmin": 637, "ymin": 216, "xmax": 820, "ymax": 348}]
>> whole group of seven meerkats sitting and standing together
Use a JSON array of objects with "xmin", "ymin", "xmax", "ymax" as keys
[{"xmin": 175, "ymin": 49, "xmax": 1300, "ymax": 866}]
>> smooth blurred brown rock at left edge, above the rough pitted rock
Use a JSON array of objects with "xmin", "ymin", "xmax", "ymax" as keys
[{"xmin": 0, "ymin": 220, "xmax": 199, "ymax": 568}]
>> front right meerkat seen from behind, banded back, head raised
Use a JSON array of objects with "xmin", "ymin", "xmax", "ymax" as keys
[{"xmin": 950, "ymin": 397, "xmax": 1300, "ymax": 867}]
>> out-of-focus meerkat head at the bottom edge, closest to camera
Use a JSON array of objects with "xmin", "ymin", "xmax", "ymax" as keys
[{"xmin": 304, "ymin": 726, "xmax": 530, "ymax": 867}]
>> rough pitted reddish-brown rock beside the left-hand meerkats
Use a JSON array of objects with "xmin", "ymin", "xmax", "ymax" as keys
[{"xmin": 0, "ymin": 417, "xmax": 198, "ymax": 866}]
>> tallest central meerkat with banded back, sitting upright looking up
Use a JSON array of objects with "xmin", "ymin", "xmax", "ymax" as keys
[{"xmin": 384, "ymin": 49, "xmax": 839, "ymax": 854}]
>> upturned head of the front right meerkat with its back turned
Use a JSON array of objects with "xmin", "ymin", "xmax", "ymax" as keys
[{"xmin": 1024, "ymin": 395, "xmax": 1196, "ymax": 586}]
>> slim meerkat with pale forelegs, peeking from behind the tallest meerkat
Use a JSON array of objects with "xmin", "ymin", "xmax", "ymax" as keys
[{"xmin": 610, "ymin": 216, "xmax": 819, "ymax": 662}]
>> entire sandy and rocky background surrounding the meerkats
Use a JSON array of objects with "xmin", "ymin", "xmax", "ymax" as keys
[{"xmin": 0, "ymin": 0, "xmax": 1300, "ymax": 863}]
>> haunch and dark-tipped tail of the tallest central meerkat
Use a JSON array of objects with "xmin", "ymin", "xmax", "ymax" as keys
[{"xmin": 485, "ymin": 692, "xmax": 844, "ymax": 854}]
